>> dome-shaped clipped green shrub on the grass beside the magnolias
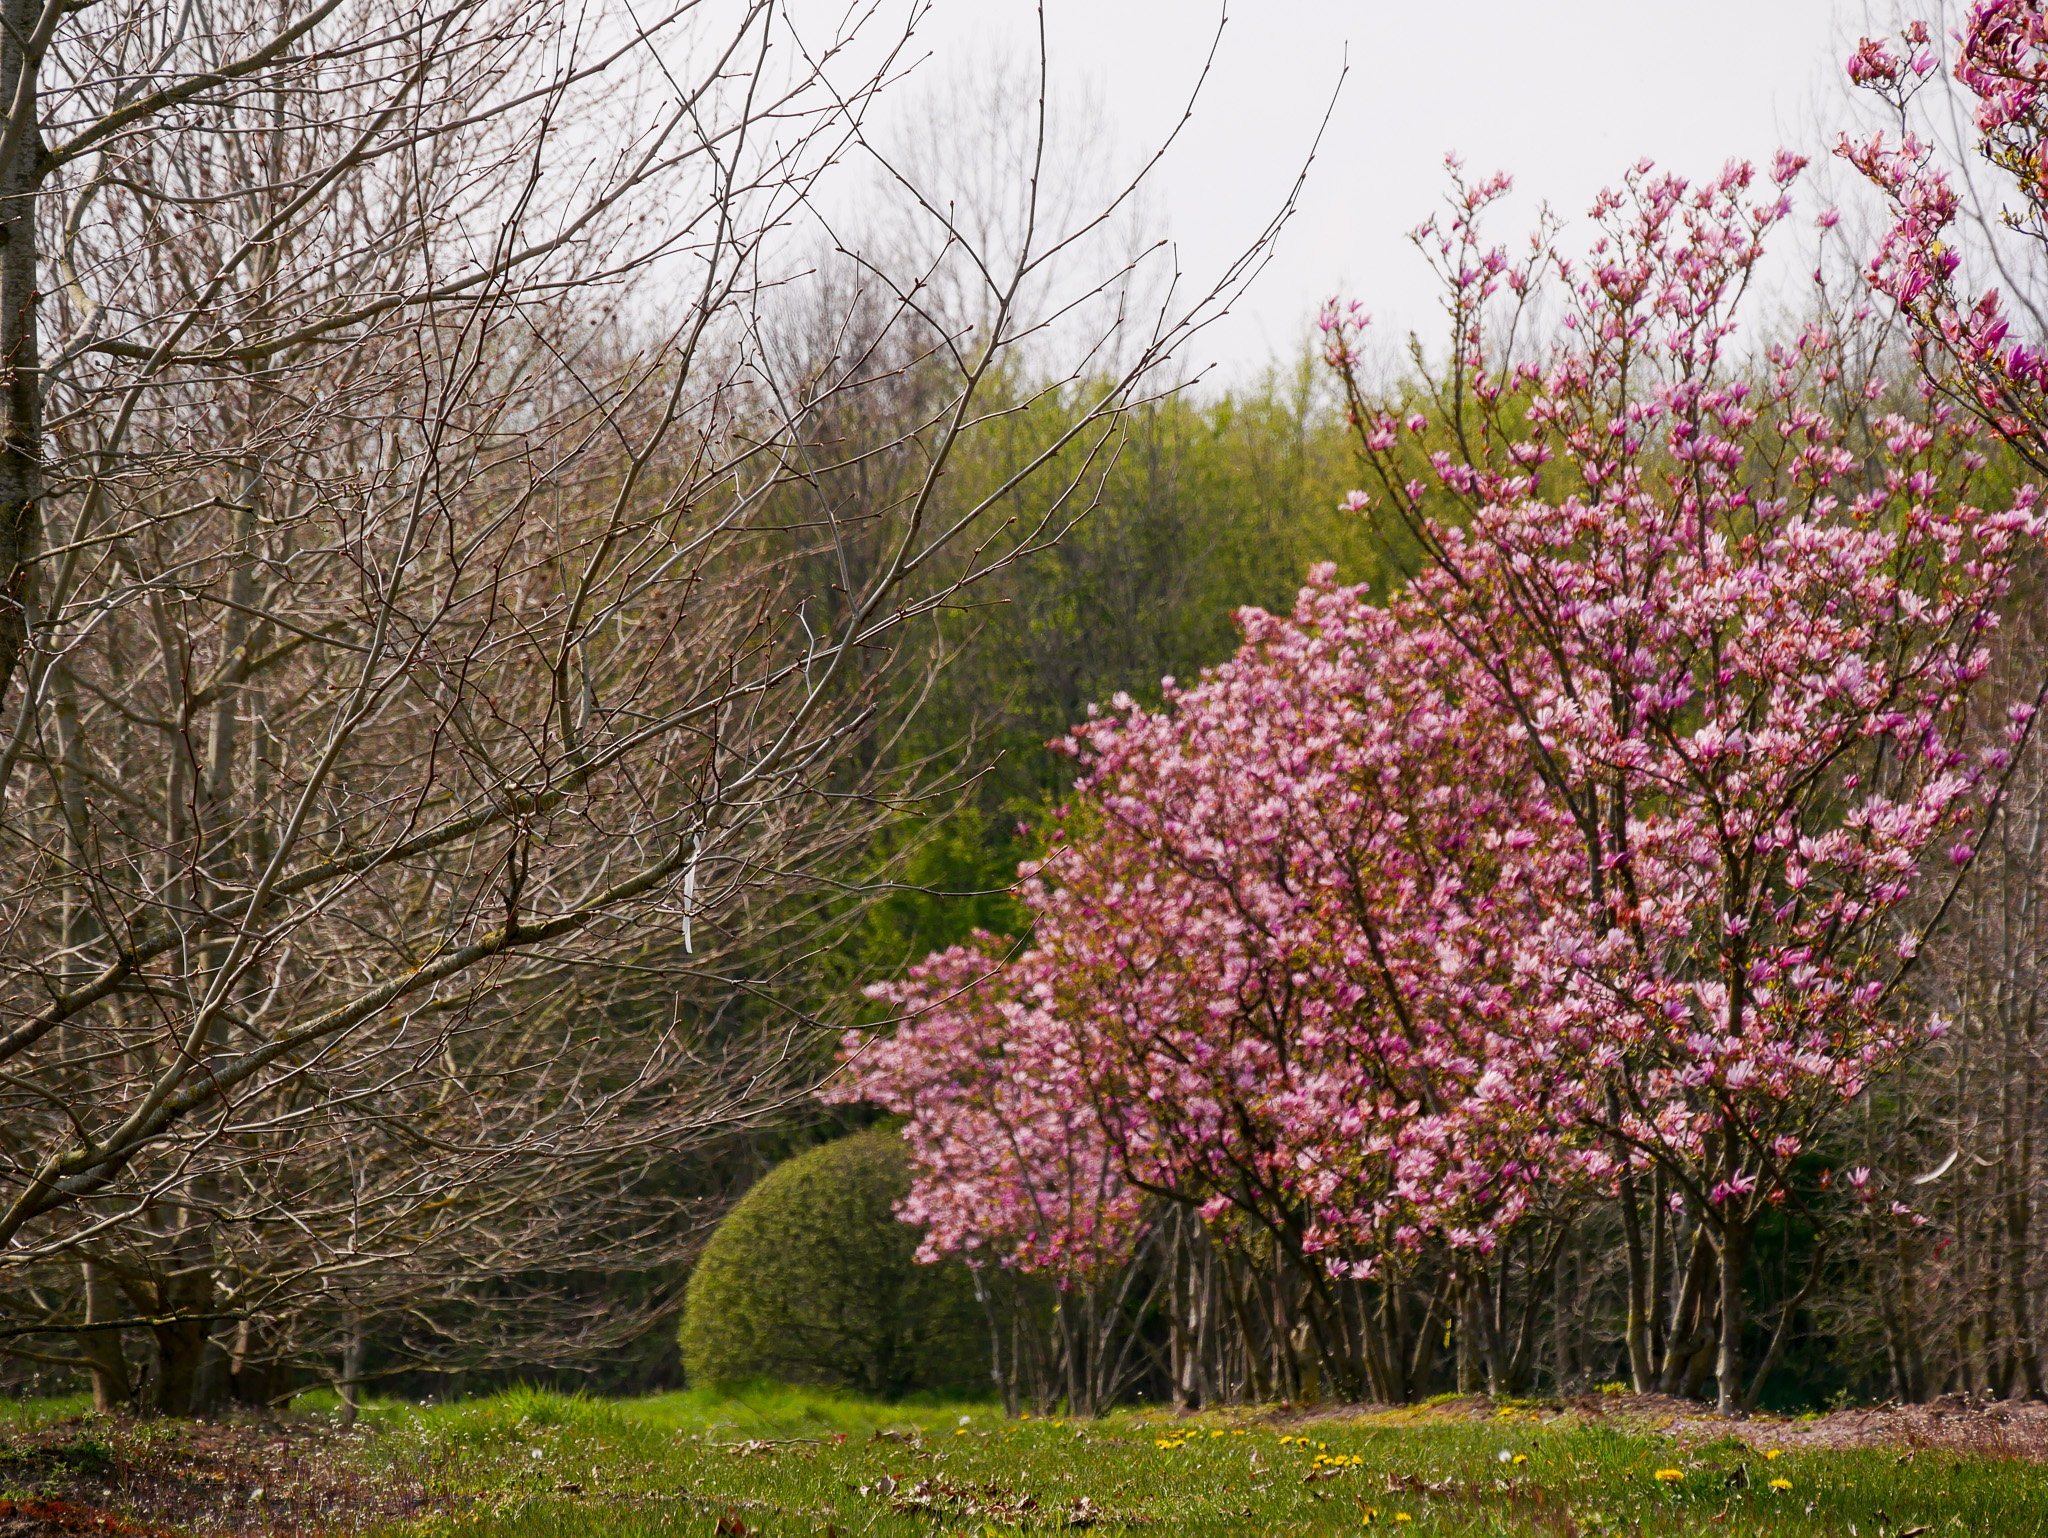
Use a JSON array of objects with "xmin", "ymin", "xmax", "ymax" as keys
[{"xmin": 682, "ymin": 1130, "xmax": 989, "ymax": 1399}]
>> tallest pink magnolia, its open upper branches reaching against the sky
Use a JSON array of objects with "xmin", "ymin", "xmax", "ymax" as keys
[{"xmin": 1325, "ymin": 156, "xmax": 2044, "ymax": 1413}]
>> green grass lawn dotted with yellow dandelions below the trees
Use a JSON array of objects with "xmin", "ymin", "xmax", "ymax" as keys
[{"xmin": 335, "ymin": 1391, "xmax": 2048, "ymax": 1538}]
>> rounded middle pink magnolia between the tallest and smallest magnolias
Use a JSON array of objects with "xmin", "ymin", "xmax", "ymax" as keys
[{"xmin": 1036, "ymin": 569, "xmax": 1569, "ymax": 1360}]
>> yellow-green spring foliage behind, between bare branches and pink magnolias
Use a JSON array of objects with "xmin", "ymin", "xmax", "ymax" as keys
[{"xmin": 840, "ymin": 358, "xmax": 1395, "ymax": 987}]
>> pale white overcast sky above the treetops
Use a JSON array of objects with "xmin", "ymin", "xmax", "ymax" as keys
[{"xmin": 856, "ymin": 0, "xmax": 1867, "ymax": 379}]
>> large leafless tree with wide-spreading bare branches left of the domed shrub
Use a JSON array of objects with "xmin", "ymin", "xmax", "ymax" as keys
[{"xmin": 0, "ymin": 0, "xmax": 1270, "ymax": 1411}]
